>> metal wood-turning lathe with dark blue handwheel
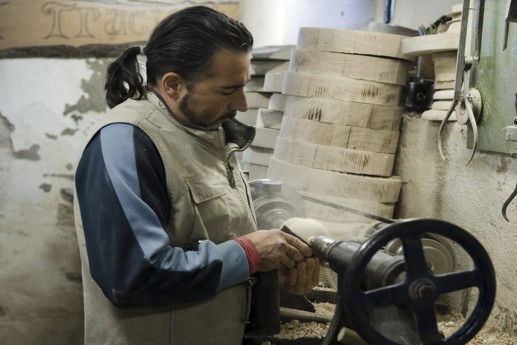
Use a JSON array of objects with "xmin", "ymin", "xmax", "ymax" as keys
[{"xmin": 244, "ymin": 179, "xmax": 496, "ymax": 345}]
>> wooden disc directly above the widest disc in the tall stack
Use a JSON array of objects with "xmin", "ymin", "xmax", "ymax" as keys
[{"xmin": 273, "ymin": 136, "xmax": 395, "ymax": 177}]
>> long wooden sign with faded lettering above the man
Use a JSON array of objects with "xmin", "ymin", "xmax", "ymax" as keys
[{"xmin": 0, "ymin": 0, "xmax": 238, "ymax": 49}]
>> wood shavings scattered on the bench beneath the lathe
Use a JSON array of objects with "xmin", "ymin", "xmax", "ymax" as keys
[{"xmin": 262, "ymin": 303, "xmax": 517, "ymax": 345}]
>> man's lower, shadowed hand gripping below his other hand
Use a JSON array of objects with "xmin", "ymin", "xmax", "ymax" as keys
[{"xmin": 278, "ymin": 257, "xmax": 320, "ymax": 295}]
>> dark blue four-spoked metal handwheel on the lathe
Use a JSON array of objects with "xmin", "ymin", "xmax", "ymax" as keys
[{"xmin": 342, "ymin": 219, "xmax": 496, "ymax": 345}]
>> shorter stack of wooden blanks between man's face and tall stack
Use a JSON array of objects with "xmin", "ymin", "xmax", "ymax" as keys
[{"xmin": 237, "ymin": 45, "xmax": 294, "ymax": 180}]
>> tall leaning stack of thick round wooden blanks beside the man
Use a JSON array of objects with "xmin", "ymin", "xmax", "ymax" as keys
[{"xmin": 268, "ymin": 28, "xmax": 412, "ymax": 237}]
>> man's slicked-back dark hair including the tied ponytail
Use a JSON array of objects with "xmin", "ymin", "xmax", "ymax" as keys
[{"xmin": 105, "ymin": 6, "xmax": 253, "ymax": 108}]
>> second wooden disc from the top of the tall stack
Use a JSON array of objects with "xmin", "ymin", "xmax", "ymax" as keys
[{"xmin": 289, "ymin": 49, "xmax": 409, "ymax": 85}]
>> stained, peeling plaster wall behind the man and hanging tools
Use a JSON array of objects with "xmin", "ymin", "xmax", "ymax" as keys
[{"xmin": 0, "ymin": 0, "xmax": 517, "ymax": 345}]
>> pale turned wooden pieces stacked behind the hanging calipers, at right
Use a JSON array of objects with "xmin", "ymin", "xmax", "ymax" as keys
[{"xmin": 402, "ymin": 4, "xmax": 462, "ymax": 121}]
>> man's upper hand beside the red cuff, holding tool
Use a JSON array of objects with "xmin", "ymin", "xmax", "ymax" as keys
[{"xmin": 243, "ymin": 229, "xmax": 312, "ymax": 274}]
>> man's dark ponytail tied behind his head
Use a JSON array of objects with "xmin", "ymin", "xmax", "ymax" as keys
[{"xmin": 104, "ymin": 47, "xmax": 144, "ymax": 108}]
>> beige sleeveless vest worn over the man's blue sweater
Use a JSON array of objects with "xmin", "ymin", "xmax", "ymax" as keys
[{"xmin": 74, "ymin": 92, "xmax": 257, "ymax": 345}]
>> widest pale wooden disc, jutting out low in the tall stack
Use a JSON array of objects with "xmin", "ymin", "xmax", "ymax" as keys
[{"xmin": 267, "ymin": 157, "xmax": 402, "ymax": 203}]
